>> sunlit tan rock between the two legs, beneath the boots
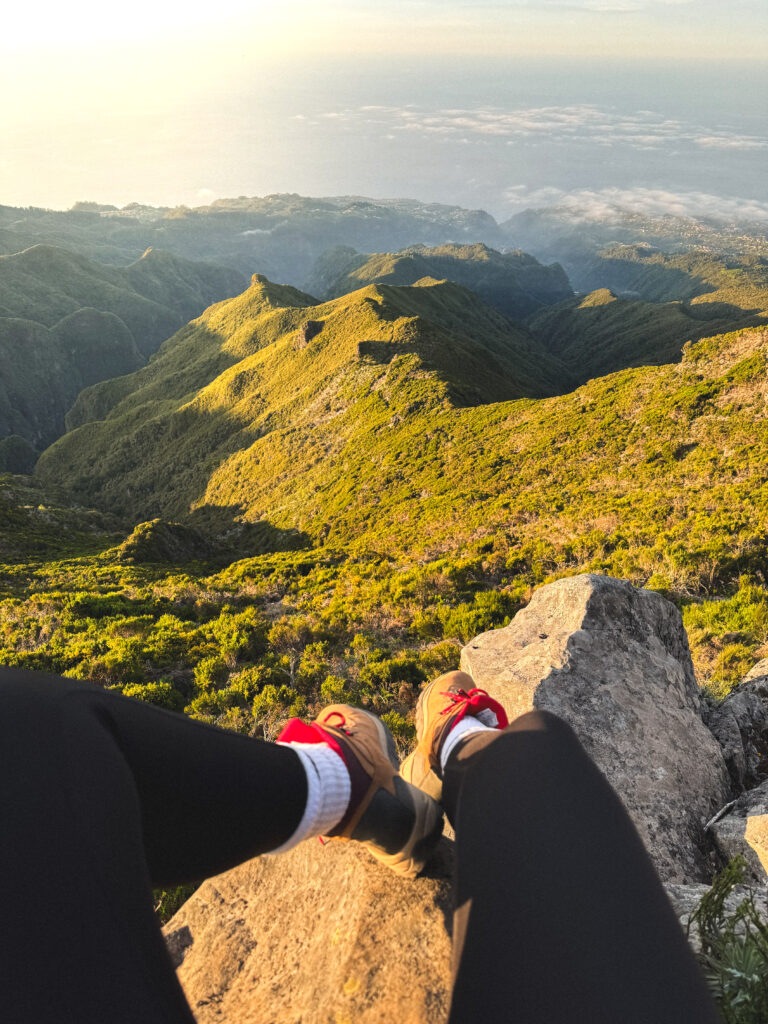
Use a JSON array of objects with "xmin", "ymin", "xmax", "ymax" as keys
[{"xmin": 165, "ymin": 840, "xmax": 452, "ymax": 1024}]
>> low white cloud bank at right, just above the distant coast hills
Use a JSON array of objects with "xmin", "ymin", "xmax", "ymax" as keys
[{"xmin": 505, "ymin": 185, "xmax": 768, "ymax": 224}]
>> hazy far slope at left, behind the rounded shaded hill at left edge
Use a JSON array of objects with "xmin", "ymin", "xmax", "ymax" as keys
[{"xmin": 0, "ymin": 245, "xmax": 245, "ymax": 358}]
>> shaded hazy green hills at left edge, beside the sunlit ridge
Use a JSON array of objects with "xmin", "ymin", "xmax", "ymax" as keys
[{"xmin": 0, "ymin": 245, "xmax": 245, "ymax": 452}]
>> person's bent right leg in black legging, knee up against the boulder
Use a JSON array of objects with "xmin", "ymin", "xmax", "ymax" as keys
[{"xmin": 442, "ymin": 712, "xmax": 720, "ymax": 1024}]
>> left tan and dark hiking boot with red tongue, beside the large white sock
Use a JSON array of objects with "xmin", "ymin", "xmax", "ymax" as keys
[{"xmin": 279, "ymin": 705, "xmax": 442, "ymax": 878}]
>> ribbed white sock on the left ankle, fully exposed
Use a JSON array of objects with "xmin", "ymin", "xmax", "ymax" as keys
[{"xmin": 270, "ymin": 743, "xmax": 352, "ymax": 853}]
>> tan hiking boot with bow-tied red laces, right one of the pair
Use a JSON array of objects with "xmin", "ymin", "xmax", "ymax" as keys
[{"xmin": 400, "ymin": 672, "xmax": 509, "ymax": 800}]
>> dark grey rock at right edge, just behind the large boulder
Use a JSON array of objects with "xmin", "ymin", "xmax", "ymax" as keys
[{"xmin": 706, "ymin": 679, "xmax": 768, "ymax": 792}]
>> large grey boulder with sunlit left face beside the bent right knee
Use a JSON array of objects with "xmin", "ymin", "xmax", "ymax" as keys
[{"xmin": 461, "ymin": 575, "xmax": 730, "ymax": 883}]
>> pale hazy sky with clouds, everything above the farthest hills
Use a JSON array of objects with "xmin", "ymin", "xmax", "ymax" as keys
[{"xmin": 0, "ymin": 0, "xmax": 768, "ymax": 216}]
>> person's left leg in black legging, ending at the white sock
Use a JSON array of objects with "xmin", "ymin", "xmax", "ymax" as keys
[{"xmin": 0, "ymin": 670, "xmax": 307, "ymax": 1024}]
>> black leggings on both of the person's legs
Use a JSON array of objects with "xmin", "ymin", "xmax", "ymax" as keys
[{"xmin": 0, "ymin": 670, "xmax": 719, "ymax": 1024}]
